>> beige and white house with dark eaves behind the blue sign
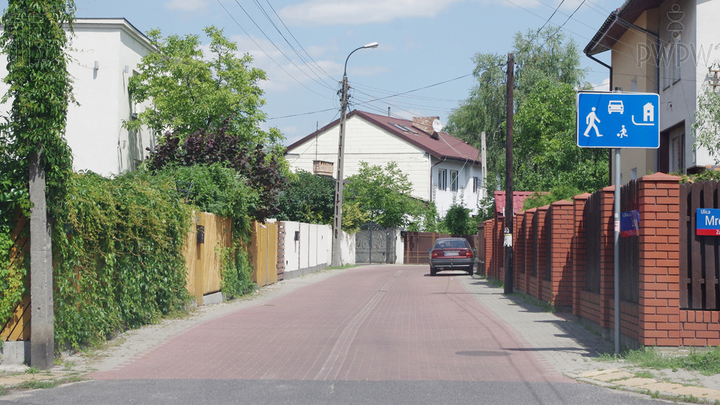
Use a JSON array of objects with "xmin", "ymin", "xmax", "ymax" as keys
[{"xmin": 585, "ymin": 0, "xmax": 720, "ymax": 183}]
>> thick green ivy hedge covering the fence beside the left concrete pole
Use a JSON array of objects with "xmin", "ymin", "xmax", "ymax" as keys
[{"xmin": 53, "ymin": 172, "xmax": 191, "ymax": 348}]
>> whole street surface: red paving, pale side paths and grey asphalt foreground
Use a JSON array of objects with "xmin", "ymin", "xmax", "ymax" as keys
[{"xmin": 0, "ymin": 265, "xmax": 717, "ymax": 404}]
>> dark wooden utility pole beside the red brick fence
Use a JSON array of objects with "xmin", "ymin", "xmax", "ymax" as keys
[{"xmin": 503, "ymin": 53, "xmax": 515, "ymax": 294}]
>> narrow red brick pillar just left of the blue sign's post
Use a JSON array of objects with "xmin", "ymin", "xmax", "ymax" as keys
[{"xmin": 600, "ymin": 186, "xmax": 615, "ymax": 330}]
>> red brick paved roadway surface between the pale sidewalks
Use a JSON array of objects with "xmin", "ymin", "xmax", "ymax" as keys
[{"xmin": 92, "ymin": 266, "xmax": 572, "ymax": 382}]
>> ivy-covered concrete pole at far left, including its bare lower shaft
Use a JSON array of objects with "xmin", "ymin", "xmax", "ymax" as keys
[{"xmin": 0, "ymin": 0, "xmax": 75, "ymax": 369}]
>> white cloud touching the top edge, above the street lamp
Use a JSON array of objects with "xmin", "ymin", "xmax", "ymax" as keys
[{"xmin": 280, "ymin": 0, "xmax": 462, "ymax": 25}]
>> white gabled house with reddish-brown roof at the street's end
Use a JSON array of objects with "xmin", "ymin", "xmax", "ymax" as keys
[{"xmin": 285, "ymin": 110, "xmax": 485, "ymax": 216}]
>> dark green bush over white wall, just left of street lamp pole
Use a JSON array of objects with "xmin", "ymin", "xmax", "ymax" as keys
[{"xmin": 276, "ymin": 170, "xmax": 336, "ymax": 225}]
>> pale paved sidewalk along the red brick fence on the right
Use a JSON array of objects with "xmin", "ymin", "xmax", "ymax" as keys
[{"xmin": 462, "ymin": 276, "xmax": 720, "ymax": 403}]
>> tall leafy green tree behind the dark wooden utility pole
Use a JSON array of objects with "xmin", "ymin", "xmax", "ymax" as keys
[{"xmin": 446, "ymin": 29, "xmax": 608, "ymax": 191}]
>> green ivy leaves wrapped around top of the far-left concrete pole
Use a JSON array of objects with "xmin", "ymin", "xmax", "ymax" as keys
[{"xmin": 0, "ymin": 0, "xmax": 75, "ymax": 218}]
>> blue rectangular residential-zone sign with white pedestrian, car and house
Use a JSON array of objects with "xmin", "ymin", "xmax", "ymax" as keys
[{"xmin": 577, "ymin": 92, "xmax": 660, "ymax": 149}]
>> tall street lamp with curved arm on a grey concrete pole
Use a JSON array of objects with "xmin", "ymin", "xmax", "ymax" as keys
[{"xmin": 330, "ymin": 42, "xmax": 378, "ymax": 267}]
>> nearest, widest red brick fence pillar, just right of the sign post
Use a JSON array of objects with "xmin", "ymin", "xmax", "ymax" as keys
[{"xmin": 638, "ymin": 173, "xmax": 680, "ymax": 346}]
